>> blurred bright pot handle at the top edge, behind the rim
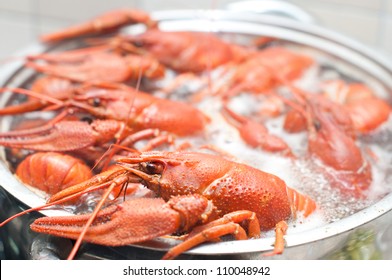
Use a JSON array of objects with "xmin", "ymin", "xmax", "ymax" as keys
[{"xmin": 226, "ymin": 0, "xmax": 316, "ymax": 24}]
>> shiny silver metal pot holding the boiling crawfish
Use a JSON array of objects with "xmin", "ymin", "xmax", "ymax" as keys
[{"xmin": 0, "ymin": 3, "xmax": 392, "ymax": 259}]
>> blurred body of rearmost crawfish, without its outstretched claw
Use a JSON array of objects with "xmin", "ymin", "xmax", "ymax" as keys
[{"xmin": 116, "ymin": 29, "xmax": 253, "ymax": 73}]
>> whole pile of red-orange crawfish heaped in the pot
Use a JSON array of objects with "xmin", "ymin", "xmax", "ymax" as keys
[{"xmin": 0, "ymin": 7, "xmax": 391, "ymax": 259}]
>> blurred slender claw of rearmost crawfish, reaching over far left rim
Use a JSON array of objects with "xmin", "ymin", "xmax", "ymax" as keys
[{"xmin": 41, "ymin": 9, "xmax": 156, "ymax": 43}]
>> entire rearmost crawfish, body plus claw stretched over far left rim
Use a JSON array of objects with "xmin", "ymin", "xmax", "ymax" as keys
[{"xmin": 41, "ymin": 9, "xmax": 253, "ymax": 72}]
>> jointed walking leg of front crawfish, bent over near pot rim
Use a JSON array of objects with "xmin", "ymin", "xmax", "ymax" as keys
[{"xmin": 163, "ymin": 210, "xmax": 260, "ymax": 259}]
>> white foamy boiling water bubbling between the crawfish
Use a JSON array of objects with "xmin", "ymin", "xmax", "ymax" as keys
[{"xmin": 155, "ymin": 57, "xmax": 392, "ymax": 235}]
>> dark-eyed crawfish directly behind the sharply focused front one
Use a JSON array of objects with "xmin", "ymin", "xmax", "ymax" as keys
[{"xmin": 2, "ymin": 83, "xmax": 210, "ymax": 136}]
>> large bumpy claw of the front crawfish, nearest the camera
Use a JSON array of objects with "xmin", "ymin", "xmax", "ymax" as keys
[{"xmin": 30, "ymin": 198, "xmax": 179, "ymax": 246}]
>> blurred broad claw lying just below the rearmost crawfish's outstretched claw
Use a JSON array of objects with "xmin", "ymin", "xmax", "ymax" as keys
[{"xmin": 26, "ymin": 46, "xmax": 165, "ymax": 82}]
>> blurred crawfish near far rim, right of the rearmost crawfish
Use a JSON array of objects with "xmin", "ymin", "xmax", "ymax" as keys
[{"xmin": 193, "ymin": 46, "xmax": 314, "ymax": 102}]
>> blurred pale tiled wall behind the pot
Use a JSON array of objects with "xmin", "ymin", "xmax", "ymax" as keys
[{"xmin": 0, "ymin": 0, "xmax": 392, "ymax": 58}]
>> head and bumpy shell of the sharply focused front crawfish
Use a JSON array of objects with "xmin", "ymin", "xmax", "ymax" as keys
[{"xmin": 119, "ymin": 152, "xmax": 291, "ymax": 229}]
